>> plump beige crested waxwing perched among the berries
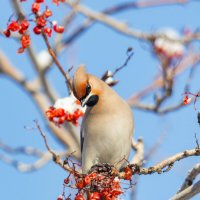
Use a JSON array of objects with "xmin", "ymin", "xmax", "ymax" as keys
[{"xmin": 72, "ymin": 65, "xmax": 134, "ymax": 173}]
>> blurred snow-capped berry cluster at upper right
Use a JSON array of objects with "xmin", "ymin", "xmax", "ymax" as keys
[{"xmin": 154, "ymin": 28, "xmax": 185, "ymax": 59}]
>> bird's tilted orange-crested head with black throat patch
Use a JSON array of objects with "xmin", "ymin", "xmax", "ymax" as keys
[{"xmin": 73, "ymin": 65, "xmax": 101, "ymax": 107}]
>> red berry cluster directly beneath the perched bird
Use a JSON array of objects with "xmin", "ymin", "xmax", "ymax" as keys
[{"xmin": 57, "ymin": 163, "xmax": 132, "ymax": 200}]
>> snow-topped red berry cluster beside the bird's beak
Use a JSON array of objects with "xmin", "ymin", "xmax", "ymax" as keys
[{"xmin": 46, "ymin": 96, "xmax": 85, "ymax": 126}]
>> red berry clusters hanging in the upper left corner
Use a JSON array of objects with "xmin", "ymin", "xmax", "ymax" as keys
[{"xmin": 4, "ymin": 0, "xmax": 64, "ymax": 53}]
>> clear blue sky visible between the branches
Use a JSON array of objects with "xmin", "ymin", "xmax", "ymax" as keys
[{"xmin": 0, "ymin": 0, "xmax": 200, "ymax": 200}]
